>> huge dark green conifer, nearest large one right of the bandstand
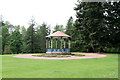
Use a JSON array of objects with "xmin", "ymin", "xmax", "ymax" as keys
[{"xmin": 75, "ymin": 1, "xmax": 105, "ymax": 52}]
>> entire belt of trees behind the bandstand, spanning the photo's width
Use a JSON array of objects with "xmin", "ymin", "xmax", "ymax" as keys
[{"xmin": 0, "ymin": 0, "xmax": 120, "ymax": 53}]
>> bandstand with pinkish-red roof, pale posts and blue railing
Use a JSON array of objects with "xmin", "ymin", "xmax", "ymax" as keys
[{"xmin": 46, "ymin": 31, "xmax": 71, "ymax": 55}]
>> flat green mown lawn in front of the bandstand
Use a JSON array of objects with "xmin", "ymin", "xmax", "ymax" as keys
[{"xmin": 2, "ymin": 54, "xmax": 118, "ymax": 78}]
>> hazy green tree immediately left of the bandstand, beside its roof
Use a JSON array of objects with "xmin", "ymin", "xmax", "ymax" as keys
[{"xmin": 35, "ymin": 23, "xmax": 50, "ymax": 52}]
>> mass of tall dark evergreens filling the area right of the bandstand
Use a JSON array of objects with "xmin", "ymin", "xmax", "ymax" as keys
[{"xmin": 73, "ymin": 1, "xmax": 120, "ymax": 52}]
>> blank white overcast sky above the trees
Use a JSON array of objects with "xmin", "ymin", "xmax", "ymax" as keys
[{"xmin": 0, "ymin": 0, "xmax": 77, "ymax": 28}]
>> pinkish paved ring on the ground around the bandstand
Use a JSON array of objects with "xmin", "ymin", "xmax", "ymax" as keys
[{"xmin": 13, "ymin": 53, "xmax": 107, "ymax": 59}]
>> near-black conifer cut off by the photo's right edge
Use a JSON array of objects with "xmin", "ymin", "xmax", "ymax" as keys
[{"xmin": 104, "ymin": 1, "xmax": 120, "ymax": 49}]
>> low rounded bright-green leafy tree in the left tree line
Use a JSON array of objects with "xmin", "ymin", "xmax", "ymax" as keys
[{"xmin": 10, "ymin": 30, "xmax": 22, "ymax": 54}]
